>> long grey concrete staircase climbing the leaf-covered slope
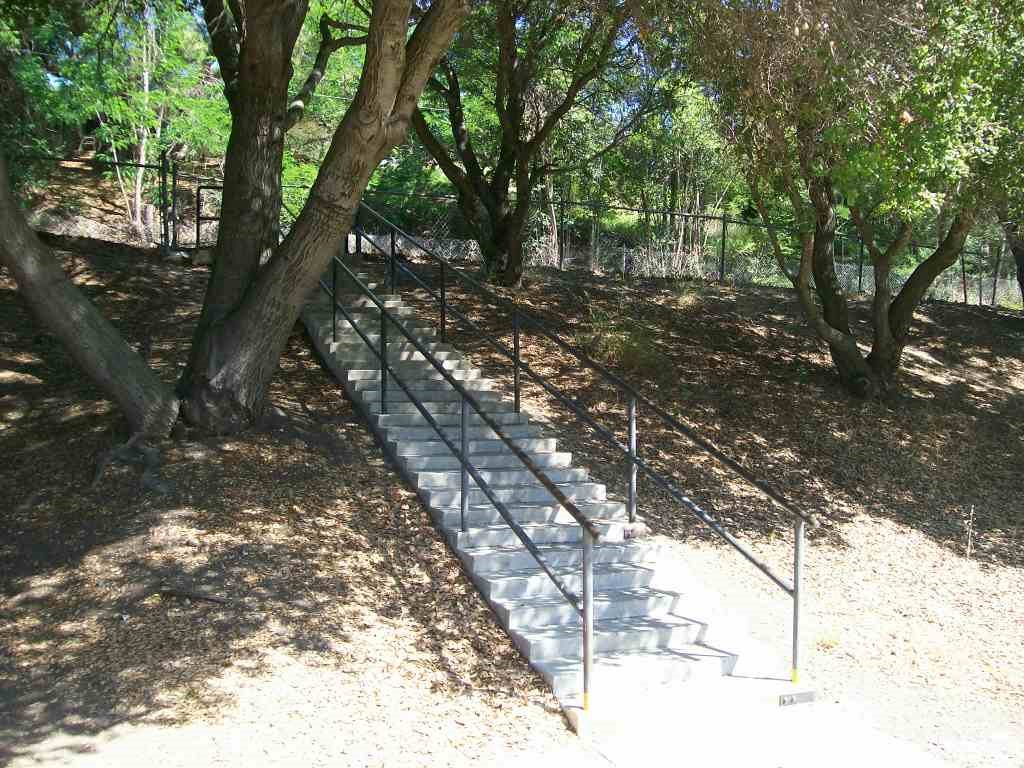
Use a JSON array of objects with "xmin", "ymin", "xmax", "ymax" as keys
[{"xmin": 303, "ymin": 273, "xmax": 737, "ymax": 706}]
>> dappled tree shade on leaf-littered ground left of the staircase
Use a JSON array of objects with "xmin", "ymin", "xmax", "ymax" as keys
[{"xmin": 0, "ymin": 243, "xmax": 549, "ymax": 763}]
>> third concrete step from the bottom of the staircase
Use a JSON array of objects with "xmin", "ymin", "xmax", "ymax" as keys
[{"xmin": 493, "ymin": 587, "xmax": 682, "ymax": 632}]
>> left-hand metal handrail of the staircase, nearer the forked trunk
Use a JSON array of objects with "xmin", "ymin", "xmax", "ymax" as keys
[{"xmin": 319, "ymin": 247, "xmax": 601, "ymax": 709}]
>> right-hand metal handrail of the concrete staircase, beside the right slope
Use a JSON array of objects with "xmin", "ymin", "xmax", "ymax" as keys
[{"xmin": 359, "ymin": 203, "xmax": 815, "ymax": 682}]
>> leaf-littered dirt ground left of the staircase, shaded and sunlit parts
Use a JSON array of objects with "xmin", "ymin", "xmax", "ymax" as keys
[{"xmin": 0, "ymin": 242, "xmax": 579, "ymax": 766}]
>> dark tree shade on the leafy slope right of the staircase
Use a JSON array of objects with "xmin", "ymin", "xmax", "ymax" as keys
[{"xmin": 380, "ymin": 257, "xmax": 1024, "ymax": 566}]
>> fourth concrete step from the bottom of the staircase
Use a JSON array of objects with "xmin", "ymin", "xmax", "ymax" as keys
[{"xmin": 473, "ymin": 563, "xmax": 654, "ymax": 606}]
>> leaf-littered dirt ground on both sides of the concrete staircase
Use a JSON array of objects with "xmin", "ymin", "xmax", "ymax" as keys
[{"xmin": 0, "ymin": 242, "xmax": 1024, "ymax": 768}]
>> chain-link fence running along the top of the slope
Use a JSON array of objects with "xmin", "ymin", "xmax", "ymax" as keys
[{"xmin": 182, "ymin": 183, "xmax": 1022, "ymax": 308}]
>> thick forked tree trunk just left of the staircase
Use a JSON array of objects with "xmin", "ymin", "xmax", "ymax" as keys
[{"xmin": 179, "ymin": 0, "xmax": 468, "ymax": 433}]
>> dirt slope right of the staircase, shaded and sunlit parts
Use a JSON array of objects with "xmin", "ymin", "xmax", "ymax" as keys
[{"xmin": 387, "ymin": 263, "xmax": 1024, "ymax": 768}]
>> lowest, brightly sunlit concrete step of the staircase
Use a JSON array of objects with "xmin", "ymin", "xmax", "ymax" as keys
[{"xmin": 531, "ymin": 643, "xmax": 737, "ymax": 707}]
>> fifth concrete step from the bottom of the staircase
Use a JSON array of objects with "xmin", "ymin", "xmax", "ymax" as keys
[{"xmin": 459, "ymin": 540, "xmax": 657, "ymax": 574}]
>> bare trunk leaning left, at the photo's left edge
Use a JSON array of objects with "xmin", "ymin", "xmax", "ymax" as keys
[{"xmin": 0, "ymin": 156, "xmax": 178, "ymax": 437}]
